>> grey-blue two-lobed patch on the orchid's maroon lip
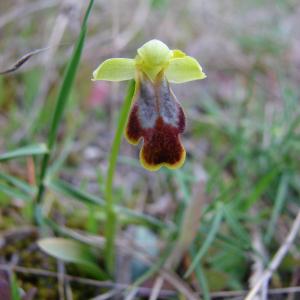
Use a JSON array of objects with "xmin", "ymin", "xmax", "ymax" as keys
[{"xmin": 138, "ymin": 75, "xmax": 179, "ymax": 128}]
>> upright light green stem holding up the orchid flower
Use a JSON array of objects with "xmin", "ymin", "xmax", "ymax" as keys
[{"xmin": 105, "ymin": 80, "xmax": 135, "ymax": 274}]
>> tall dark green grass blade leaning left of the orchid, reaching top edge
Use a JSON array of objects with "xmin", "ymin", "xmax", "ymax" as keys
[{"xmin": 35, "ymin": 0, "xmax": 94, "ymax": 224}]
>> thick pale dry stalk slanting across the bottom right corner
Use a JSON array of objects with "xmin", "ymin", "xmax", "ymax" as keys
[{"xmin": 245, "ymin": 210, "xmax": 300, "ymax": 300}]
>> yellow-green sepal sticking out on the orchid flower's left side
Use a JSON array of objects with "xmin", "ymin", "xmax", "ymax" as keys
[{"xmin": 93, "ymin": 58, "xmax": 135, "ymax": 81}]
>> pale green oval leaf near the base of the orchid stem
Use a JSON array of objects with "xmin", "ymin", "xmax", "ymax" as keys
[{"xmin": 38, "ymin": 238, "xmax": 107, "ymax": 279}]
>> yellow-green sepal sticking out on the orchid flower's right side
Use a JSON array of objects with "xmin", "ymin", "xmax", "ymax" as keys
[{"xmin": 166, "ymin": 52, "xmax": 206, "ymax": 83}]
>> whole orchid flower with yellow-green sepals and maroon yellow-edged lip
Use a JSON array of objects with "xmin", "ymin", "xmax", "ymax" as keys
[{"xmin": 93, "ymin": 40, "xmax": 206, "ymax": 171}]
